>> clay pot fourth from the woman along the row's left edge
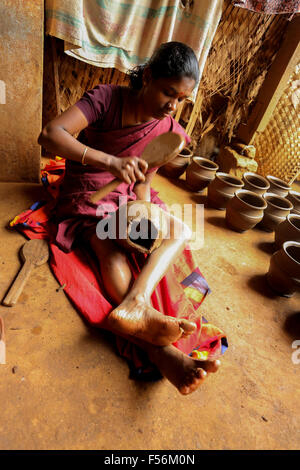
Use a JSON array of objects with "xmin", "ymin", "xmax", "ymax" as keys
[{"xmin": 226, "ymin": 189, "xmax": 267, "ymax": 232}]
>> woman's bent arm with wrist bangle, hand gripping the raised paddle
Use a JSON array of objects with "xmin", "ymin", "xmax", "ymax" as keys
[{"xmin": 38, "ymin": 105, "xmax": 147, "ymax": 184}]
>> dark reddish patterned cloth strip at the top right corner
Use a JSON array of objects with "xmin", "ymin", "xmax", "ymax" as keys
[{"xmin": 233, "ymin": 0, "xmax": 300, "ymax": 14}]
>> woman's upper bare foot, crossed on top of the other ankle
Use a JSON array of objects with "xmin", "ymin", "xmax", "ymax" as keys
[{"xmin": 103, "ymin": 295, "xmax": 196, "ymax": 346}]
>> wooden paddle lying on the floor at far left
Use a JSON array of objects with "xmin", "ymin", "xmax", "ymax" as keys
[{"xmin": 2, "ymin": 239, "xmax": 49, "ymax": 307}]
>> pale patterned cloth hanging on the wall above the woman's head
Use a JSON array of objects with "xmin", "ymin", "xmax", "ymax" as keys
[{"xmin": 46, "ymin": 0, "xmax": 223, "ymax": 80}]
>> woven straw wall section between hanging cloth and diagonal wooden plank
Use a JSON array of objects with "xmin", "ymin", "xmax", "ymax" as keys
[{"xmin": 187, "ymin": 1, "xmax": 288, "ymax": 146}]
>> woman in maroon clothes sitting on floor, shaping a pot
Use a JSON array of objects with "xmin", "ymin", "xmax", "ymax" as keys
[{"xmin": 39, "ymin": 42, "xmax": 223, "ymax": 394}]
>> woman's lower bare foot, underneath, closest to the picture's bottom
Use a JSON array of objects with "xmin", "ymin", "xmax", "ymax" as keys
[{"xmin": 147, "ymin": 345, "xmax": 220, "ymax": 395}]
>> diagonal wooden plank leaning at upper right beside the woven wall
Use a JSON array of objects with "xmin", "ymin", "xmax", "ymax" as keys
[{"xmin": 237, "ymin": 16, "xmax": 300, "ymax": 144}]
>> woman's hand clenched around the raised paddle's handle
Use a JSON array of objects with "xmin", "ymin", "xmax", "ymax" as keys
[{"xmin": 107, "ymin": 155, "xmax": 148, "ymax": 184}]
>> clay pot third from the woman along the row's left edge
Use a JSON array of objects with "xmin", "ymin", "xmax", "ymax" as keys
[{"xmin": 207, "ymin": 172, "xmax": 244, "ymax": 210}]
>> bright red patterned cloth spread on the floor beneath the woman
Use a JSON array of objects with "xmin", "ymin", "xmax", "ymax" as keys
[{"xmin": 10, "ymin": 158, "xmax": 227, "ymax": 380}]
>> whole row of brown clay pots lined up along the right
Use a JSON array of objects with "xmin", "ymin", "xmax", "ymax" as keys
[{"xmin": 165, "ymin": 154, "xmax": 300, "ymax": 297}]
